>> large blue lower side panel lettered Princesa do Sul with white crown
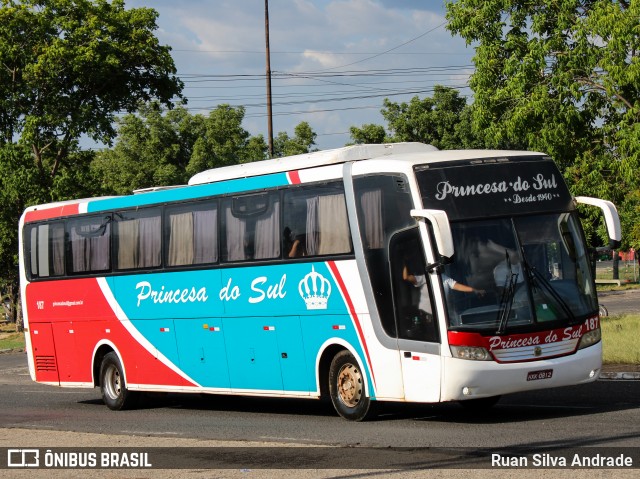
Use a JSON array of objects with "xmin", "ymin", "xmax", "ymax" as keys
[{"xmin": 111, "ymin": 262, "xmax": 371, "ymax": 393}]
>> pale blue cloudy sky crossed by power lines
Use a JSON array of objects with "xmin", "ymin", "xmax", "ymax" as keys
[{"xmin": 126, "ymin": 0, "xmax": 473, "ymax": 149}]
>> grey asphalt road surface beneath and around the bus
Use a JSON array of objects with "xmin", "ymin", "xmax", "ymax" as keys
[{"xmin": 0, "ymin": 353, "xmax": 640, "ymax": 448}]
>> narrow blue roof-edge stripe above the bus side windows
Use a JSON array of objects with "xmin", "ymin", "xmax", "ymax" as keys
[{"xmin": 87, "ymin": 173, "xmax": 289, "ymax": 213}]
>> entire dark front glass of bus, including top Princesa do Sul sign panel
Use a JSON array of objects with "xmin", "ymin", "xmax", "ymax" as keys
[{"xmin": 416, "ymin": 155, "xmax": 598, "ymax": 334}]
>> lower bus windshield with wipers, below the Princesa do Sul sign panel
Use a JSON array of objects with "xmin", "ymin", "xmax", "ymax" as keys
[{"xmin": 441, "ymin": 213, "xmax": 598, "ymax": 334}]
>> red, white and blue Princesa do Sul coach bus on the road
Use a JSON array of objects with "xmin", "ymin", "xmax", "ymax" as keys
[{"xmin": 20, "ymin": 143, "xmax": 620, "ymax": 421}]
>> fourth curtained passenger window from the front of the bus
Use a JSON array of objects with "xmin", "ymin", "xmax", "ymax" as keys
[{"xmin": 115, "ymin": 208, "xmax": 162, "ymax": 270}]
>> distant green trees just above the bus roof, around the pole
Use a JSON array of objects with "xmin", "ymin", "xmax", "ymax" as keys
[{"xmin": 91, "ymin": 104, "xmax": 316, "ymax": 194}]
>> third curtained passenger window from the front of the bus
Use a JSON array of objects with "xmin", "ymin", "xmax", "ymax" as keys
[{"xmin": 165, "ymin": 201, "xmax": 218, "ymax": 266}]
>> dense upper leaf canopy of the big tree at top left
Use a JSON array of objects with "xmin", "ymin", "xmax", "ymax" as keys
[{"xmin": 0, "ymin": 0, "xmax": 182, "ymax": 169}]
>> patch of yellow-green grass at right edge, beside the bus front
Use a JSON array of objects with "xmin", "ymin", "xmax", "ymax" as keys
[{"xmin": 601, "ymin": 314, "xmax": 640, "ymax": 364}]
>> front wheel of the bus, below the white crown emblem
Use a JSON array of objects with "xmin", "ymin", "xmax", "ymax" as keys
[{"xmin": 329, "ymin": 351, "xmax": 374, "ymax": 421}]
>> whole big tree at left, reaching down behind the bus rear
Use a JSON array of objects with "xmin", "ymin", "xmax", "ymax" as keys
[{"xmin": 0, "ymin": 0, "xmax": 183, "ymax": 326}]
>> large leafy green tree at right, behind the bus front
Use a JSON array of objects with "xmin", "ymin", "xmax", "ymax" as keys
[{"xmin": 447, "ymin": 0, "xmax": 640, "ymax": 245}]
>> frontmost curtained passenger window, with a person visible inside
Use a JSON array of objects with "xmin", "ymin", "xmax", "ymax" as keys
[{"xmin": 282, "ymin": 183, "xmax": 353, "ymax": 258}]
